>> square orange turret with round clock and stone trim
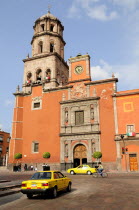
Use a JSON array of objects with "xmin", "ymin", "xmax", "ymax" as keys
[{"xmin": 69, "ymin": 54, "xmax": 91, "ymax": 82}]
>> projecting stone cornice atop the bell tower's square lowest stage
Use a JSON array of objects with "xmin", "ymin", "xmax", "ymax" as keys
[{"xmin": 23, "ymin": 52, "xmax": 69, "ymax": 68}]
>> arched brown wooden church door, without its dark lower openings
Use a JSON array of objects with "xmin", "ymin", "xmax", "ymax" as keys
[{"xmin": 73, "ymin": 144, "xmax": 87, "ymax": 165}]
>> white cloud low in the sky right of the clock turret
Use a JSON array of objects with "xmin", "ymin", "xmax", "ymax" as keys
[{"xmin": 91, "ymin": 60, "xmax": 139, "ymax": 90}]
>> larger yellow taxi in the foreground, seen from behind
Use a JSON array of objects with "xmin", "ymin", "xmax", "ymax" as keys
[{"xmin": 21, "ymin": 171, "xmax": 72, "ymax": 199}]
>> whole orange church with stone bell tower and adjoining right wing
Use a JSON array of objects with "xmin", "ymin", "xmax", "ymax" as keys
[{"xmin": 8, "ymin": 12, "xmax": 139, "ymax": 171}]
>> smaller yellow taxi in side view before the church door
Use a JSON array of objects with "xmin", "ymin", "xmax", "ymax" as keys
[{"xmin": 67, "ymin": 165, "xmax": 96, "ymax": 175}]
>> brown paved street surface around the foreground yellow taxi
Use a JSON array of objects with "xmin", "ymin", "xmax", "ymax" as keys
[{"xmin": 0, "ymin": 172, "xmax": 139, "ymax": 210}]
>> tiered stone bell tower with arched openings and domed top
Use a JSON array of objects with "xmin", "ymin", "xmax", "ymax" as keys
[{"xmin": 23, "ymin": 12, "xmax": 68, "ymax": 93}]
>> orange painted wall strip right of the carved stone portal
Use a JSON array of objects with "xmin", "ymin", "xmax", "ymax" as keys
[{"xmin": 90, "ymin": 83, "xmax": 116, "ymax": 162}]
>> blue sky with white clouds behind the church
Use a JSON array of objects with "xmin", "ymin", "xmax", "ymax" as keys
[{"xmin": 0, "ymin": 0, "xmax": 139, "ymax": 132}]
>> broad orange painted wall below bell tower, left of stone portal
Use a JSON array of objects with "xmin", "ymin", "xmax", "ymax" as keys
[{"xmin": 19, "ymin": 87, "xmax": 68, "ymax": 163}]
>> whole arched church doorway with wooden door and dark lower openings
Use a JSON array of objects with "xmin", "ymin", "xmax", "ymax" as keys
[{"xmin": 73, "ymin": 144, "xmax": 87, "ymax": 167}]
